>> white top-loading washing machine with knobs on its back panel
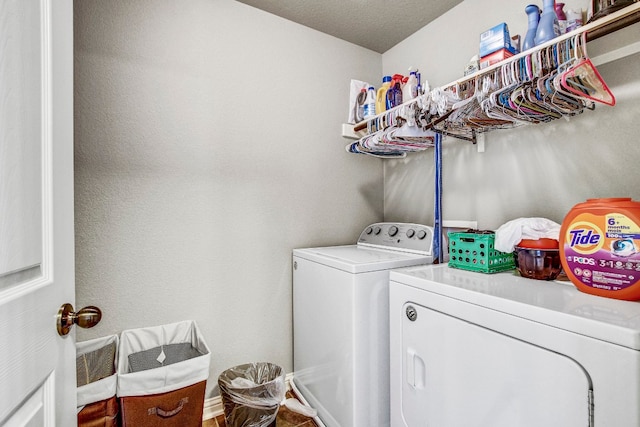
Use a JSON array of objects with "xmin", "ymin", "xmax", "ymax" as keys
[{"xmin": 293, "ymin": 223, "xmax": 433, "ymax": 427}]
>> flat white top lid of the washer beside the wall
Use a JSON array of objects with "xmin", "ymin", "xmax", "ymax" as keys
[{"xmin": 293, "ymin": 245, "xmax": 433, "ymax": 274}]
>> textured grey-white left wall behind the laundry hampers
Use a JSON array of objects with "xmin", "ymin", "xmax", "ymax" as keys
[{"xmin": 74, "ymin": 0, "xmax": 383, "ymax": 395}]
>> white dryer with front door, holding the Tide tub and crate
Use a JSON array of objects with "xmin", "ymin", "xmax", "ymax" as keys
[{"xmin": 389, "ymin": 264, "xmax": 640, "ymax": 427}]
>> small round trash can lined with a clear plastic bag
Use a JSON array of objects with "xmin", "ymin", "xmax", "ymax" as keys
[{"xmin": 218, "ymin": 362, "xmax": 286, "ymax": 427}]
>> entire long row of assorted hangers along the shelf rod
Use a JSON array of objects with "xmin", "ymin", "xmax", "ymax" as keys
[{"xmin": 346, "ymin": 33, "xmax": 615, "ymax": 158}]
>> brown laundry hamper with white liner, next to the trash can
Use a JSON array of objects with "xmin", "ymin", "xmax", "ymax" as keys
[{"xmin": 117, "ymin": 321, "xmax": 210, "ymax": 427}]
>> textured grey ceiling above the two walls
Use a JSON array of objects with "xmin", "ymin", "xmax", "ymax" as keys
[{"xmin": 232, "ymin": 0, "xmax": 462, "ymax": 53}]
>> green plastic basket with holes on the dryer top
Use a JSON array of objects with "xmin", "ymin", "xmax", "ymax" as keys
[{"xmin": 448, "ymin": 231, "xmax": 515, "ymax": 273}]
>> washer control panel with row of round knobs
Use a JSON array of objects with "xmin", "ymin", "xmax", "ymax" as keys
[{"xmin": 358, "ymin": 222, "xmax": 433, "ymax": 255}]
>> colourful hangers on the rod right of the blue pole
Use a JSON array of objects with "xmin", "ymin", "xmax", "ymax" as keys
[{"xmin": 436, "ymin": 33, "xmax": 615, "ymax": 140}]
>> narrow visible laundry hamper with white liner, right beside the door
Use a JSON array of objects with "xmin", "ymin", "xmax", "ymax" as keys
[{"xmin": 76, "ymin": 335, "xmax": 120, "ymax": 427}]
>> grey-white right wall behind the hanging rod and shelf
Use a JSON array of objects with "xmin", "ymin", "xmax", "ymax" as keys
[{"xmin": 383, "ymin": 0, "xmax": 640, "ymax": 229}]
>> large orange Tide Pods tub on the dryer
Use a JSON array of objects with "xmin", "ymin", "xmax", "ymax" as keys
[{"xmin": 560, "ymin": 198, "xmax": 640, "ymax": 301}]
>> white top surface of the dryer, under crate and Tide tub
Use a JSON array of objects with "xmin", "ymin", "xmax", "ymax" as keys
[{"xmin": 390, "ymin": 264, "xmax": 640, "ymax": 350}]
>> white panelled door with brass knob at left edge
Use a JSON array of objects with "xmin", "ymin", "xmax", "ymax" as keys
[{"xmin": 0, "ymin": 0, "xmax": 76, "ymax": 427}]
